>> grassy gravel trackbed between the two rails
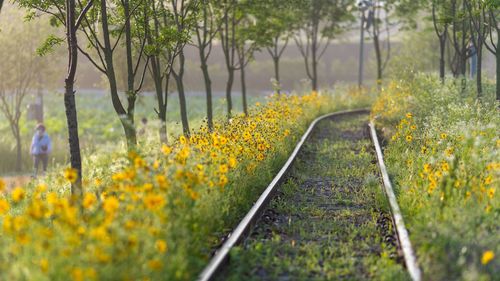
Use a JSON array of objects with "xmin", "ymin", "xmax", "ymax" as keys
[{"xmin": 220, "ymin": 114, "xmax": 408, "ymax": 280}]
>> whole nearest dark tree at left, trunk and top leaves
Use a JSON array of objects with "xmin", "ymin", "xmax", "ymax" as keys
[{"xmin": 18, "ymin": 0, "xmax": 93, "ymax": 192}]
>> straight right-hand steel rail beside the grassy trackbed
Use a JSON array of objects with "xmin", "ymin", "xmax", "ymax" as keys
[{"xmin": 369, "ymin": 121, "xmax": 422, "ymax": 281}]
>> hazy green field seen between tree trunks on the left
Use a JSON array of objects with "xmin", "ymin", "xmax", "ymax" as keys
[{"xmin": 0, "ymin": 92, "xmax": 264, "ymax": 176}]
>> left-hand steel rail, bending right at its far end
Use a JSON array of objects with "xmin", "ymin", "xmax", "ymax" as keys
[{"xmin": 198, "ymin": 109, "xmax": 369, "ymax": 281}]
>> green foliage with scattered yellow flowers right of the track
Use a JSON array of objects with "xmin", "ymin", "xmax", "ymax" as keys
[{"xmin": 373, "ymin": 74, "xmax": 500, "ymax": 280}]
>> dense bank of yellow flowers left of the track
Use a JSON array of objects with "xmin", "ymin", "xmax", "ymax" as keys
[{"xmin": 0, "ymin": 89, "xmax": 376, "ymax": 280}]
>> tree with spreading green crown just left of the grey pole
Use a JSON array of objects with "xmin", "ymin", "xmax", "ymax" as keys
[{"xmin": 294, "ymin": 0, "xmax": 353, "ymax": 91}]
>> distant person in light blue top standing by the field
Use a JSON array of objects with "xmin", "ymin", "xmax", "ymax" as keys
[{"xmin": 30, "ymin": 124, "xmax": 52, "ymax": 178}]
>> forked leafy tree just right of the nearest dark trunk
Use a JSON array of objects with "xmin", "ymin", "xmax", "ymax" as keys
[{"xmin": 78, "ymin": 0, "xmax": 147, "ymax": 149}]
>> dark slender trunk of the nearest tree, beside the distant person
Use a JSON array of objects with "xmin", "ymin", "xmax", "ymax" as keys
[{"xmin": 64, "ymin": 0, "xmax": 82, "ymax": 196}]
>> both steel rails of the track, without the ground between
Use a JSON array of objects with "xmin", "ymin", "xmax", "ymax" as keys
[{"xmin": 198, "ymin": 109, "xmax": 421, "ymax": 281}]
